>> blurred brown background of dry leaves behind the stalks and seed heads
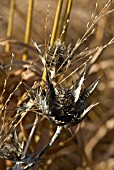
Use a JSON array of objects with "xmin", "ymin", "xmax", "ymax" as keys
[{"xmin": 0, "ymin": 0, "xmax": 114, "ymax": 170}]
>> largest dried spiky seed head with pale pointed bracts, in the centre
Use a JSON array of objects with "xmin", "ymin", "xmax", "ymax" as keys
[{"xmin": 35, "ymin": 65, "xmax": 99, "ymax": 127}]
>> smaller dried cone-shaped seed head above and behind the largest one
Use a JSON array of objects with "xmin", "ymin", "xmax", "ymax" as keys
[{"xmin": 33, "ymin": 39, "xmax": 72, "ymax": 78}]
